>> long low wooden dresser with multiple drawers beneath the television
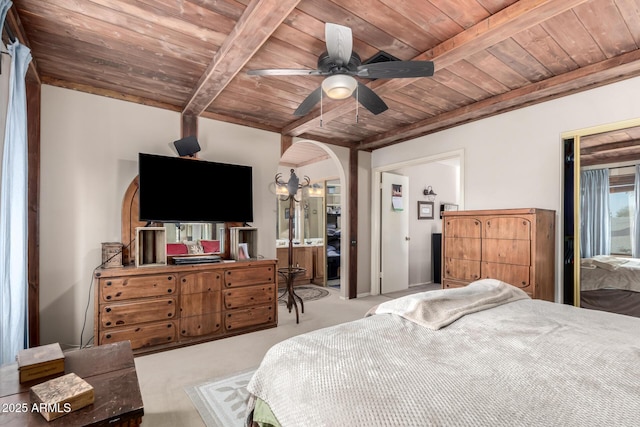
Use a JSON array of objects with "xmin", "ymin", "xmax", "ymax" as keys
[{"xmin": 94, "ymin": 260, "xmax": 278, "ymax": 354}]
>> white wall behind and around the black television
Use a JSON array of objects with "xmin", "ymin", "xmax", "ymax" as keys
[{"xmin": 40, "ymin": 85, "xmax": 280, "ymax": 346}]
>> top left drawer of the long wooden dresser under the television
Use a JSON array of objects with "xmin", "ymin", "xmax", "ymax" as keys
[{"xmin": 100, "ymin": 274, "xmax": 177, "ymax": 302}]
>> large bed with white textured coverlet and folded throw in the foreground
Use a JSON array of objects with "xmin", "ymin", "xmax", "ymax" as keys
[{"xmin": 246, "ymin": 279, "xmax": 640, "ymax": 427}]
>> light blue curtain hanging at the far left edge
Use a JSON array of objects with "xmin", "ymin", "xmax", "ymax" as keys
[{"xmin": 0, "ymin": 36, "xmax": 31, "ymax": 364}]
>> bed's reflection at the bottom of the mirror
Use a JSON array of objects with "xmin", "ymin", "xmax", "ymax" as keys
[{"xmin": 580, "ymin": 255, "xmax": 640, "ymax": 317}]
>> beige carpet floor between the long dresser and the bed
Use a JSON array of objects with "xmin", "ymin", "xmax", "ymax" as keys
[{"xmin": 135, "ymin": 286, "xmax": 437, "ymax": 427}]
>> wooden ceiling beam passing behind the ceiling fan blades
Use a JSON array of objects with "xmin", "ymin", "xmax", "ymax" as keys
[{"xmin": 283, "ymin": 0, "xmax": 588, "ymax": 136}]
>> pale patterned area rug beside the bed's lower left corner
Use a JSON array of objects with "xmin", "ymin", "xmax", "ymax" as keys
[{"xmin": 185, "ymin": 369, "xmax": 255, "ymax": 427}]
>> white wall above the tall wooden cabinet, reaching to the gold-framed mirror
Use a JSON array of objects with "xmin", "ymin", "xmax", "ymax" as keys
[{"xmin": 372, "ymin": 77, "xmax": 640, "ymax": 300}]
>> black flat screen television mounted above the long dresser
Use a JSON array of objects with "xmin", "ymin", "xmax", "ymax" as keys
[{"xmin": 138, "ymin": 153, "xmax": 253, "ymax": 222}]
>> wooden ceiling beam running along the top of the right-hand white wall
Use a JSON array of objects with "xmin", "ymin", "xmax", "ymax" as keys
[{"xmin": 359, "ymin": 51, "xmax": 640, "ymax": 150}]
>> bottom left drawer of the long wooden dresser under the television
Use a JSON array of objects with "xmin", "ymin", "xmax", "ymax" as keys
[{"xmin": 100, "ymin": 321, "xmax": 176, "ymax": 350}]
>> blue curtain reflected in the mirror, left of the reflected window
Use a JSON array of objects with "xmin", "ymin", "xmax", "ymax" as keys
[{"xmin": 580, "ymin": 169, "xmax": 611, "ymax": 258}]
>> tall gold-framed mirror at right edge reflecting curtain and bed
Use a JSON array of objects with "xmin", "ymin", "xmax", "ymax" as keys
[{"xmin": 562, "ymin": 119, "xmax": 640, "ymax": 317}]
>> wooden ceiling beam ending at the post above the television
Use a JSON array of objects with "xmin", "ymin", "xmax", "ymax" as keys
[{"xmin": 183, "ymin": 0, "xmax": 300, "ymax": 116}]
